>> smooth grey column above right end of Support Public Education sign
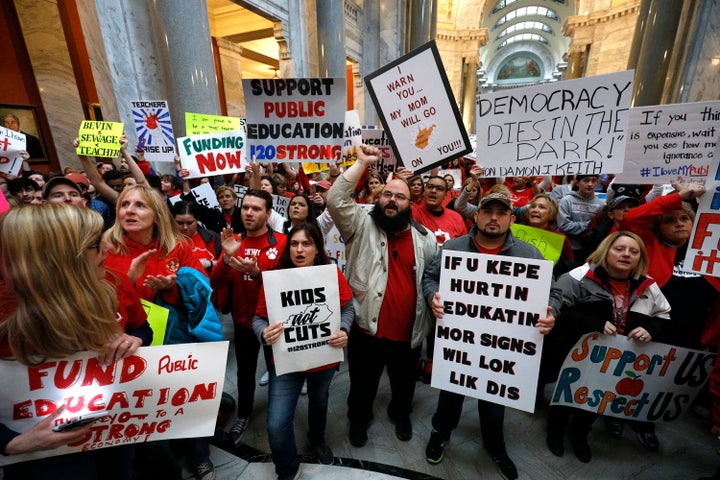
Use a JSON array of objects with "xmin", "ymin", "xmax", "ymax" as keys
[{"xmin": 316, "ymin": 0, "xmax": 345, "ymax": 77}]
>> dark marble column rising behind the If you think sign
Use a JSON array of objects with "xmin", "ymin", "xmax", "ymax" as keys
[{"xmin": 632, "ymin": 0, "xmax": 682, "ymax": 107}]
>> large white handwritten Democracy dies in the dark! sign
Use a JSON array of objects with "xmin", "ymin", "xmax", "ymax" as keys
[{"xmin": 475, "ymin": 70, "xmax": 633, "ymax": 177}]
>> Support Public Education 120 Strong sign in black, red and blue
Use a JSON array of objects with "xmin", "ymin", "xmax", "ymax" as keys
[{"xmin": 242, "ymin": 78, "xmax": 346, "ymax": 163}]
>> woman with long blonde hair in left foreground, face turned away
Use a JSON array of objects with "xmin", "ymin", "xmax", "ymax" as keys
[{"xmin": 0, "ymin": 204, "xmax": 151, "ymax": 480}]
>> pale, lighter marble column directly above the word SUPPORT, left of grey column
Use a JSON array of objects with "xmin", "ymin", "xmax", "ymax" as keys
[{"xmin": 288, "ymin": 0, "xmax": 318, "ymax": 78}]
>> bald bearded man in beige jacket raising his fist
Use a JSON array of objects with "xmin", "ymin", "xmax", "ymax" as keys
[{"xmin": 327, "ymin": 145, "xmax": 437, "ymax": 447}]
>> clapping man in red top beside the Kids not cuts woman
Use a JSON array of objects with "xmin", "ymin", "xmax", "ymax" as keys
[{"xmin": 210, "ymin": 189, "xmax": 285, "ymax": 445}]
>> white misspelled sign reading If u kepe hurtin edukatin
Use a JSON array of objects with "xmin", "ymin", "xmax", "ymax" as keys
[{"xmin": 432, "ymin": 250, "xmax": 552, "ymax": 413}]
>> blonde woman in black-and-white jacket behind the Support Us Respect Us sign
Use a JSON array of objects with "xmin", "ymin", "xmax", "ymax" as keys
[{"xmin": 543, "ymin": 231, "xmax": 670, "ymax": 463}]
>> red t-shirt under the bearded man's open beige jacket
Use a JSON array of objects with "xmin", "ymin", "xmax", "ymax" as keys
[{"xmin": 376, "ymin": 228, "xmax": 417, "ymax": 342}]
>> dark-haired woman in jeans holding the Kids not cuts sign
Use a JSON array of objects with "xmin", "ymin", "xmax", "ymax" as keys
[{"xmin": 253, "ymin": 223, "xmax": 354, "ymax": 479}]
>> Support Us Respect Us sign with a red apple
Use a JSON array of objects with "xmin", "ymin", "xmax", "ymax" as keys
[{"xmin": 551, "ymin": 332, "xmax": 717, "ymax": 422}]
